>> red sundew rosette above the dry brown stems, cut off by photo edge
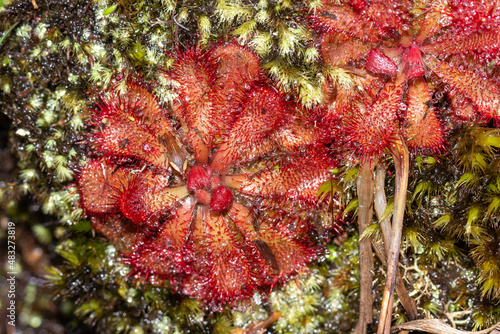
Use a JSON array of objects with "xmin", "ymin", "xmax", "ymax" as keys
[{"xmin": 311, "ymin": 0, "xmax": 500, "ymax": 156}]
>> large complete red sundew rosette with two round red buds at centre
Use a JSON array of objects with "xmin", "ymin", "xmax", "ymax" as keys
[{"xmin": 78, "ymin": 43, "xmax": 335, "ymax": 309}]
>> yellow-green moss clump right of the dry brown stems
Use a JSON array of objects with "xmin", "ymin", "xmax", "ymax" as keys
[{"xmin": 398, "ymin": 125, "xmax": 500, "ymax": 329}]
